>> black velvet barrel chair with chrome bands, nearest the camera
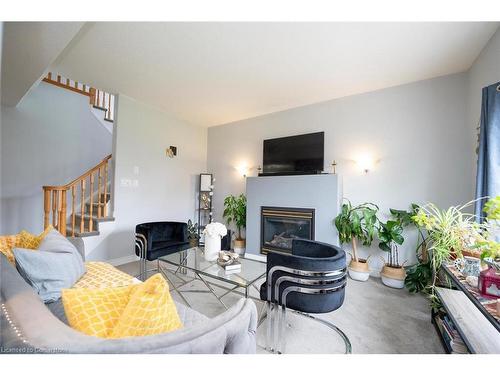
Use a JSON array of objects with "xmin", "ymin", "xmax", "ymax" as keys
[{"xmin": 260, "ymin": 240, "xmax": 351, "ymax": 353}]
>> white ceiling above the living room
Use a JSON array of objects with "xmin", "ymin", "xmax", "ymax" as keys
[{"xmin": 55, "ymin": 22, "xmax": 498, "ymax": 126}]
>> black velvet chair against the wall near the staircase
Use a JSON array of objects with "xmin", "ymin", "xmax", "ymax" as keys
[{"xmin": 135, "ymin": 221, "xmax": 190, "ymax": 280}]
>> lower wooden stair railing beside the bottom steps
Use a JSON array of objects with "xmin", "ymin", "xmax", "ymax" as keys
[{"xmin": 43, "ymin": 155, "xmax": 111, "ymax": 237}]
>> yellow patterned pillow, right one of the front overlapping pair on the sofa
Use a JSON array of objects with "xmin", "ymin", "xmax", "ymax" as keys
[{"xmin": 109, "ymin": 274, "xmax": 182, "ymax": 338}]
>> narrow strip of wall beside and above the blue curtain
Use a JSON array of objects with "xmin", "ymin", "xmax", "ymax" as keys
[{"xmin": 467, "ymin": 29, "xmax": 500, "ymax": 188}]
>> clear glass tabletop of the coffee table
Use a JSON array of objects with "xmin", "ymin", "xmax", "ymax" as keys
[{"xmin": 158, "ymin": 247, "xmax": 266, "ymax": 288}]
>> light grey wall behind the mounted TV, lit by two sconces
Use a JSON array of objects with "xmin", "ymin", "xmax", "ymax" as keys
[{"xmin": 208, "ymin": 74, "xmax": 473, "ymax": 274}]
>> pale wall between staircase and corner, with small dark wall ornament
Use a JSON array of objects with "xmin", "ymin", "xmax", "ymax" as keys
[{"xmin": 86, "ymin": 95, "xmax": 207, "ymax": 260}]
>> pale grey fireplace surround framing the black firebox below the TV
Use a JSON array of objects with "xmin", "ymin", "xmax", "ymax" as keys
[{"xmin": 246, "ymin": 174, "xmax": 342, "ymax": 255}]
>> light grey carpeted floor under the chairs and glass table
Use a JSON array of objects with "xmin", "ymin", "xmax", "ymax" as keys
[{"xmin": 118, "ymin": 262, "xmax": 443, "ymax": 354}]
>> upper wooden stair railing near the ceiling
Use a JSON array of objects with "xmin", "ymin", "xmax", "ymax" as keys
[{"xmin": 42, "ymin": 73, "xmax": 115, "ymax": 122}]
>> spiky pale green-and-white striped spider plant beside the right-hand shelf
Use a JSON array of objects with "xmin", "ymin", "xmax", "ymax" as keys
[{"xmin": 413, "ymin": 201, "xmax": 488, "ymax": 302}]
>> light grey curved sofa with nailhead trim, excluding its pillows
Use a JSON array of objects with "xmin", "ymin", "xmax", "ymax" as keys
[{"xmin": 0, "ymin": 239, "xmax": 257, "ymax": 354}]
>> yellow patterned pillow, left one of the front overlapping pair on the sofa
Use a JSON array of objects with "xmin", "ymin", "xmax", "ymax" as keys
[{"xmin": 62, "ymin": 285, "xmax": 134, "ymax": 338}]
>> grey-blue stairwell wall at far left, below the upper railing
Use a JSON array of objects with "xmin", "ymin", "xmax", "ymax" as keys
[{"xmin": 0, "ymin": 82, "xmax": 112, "ymax": 234}]
